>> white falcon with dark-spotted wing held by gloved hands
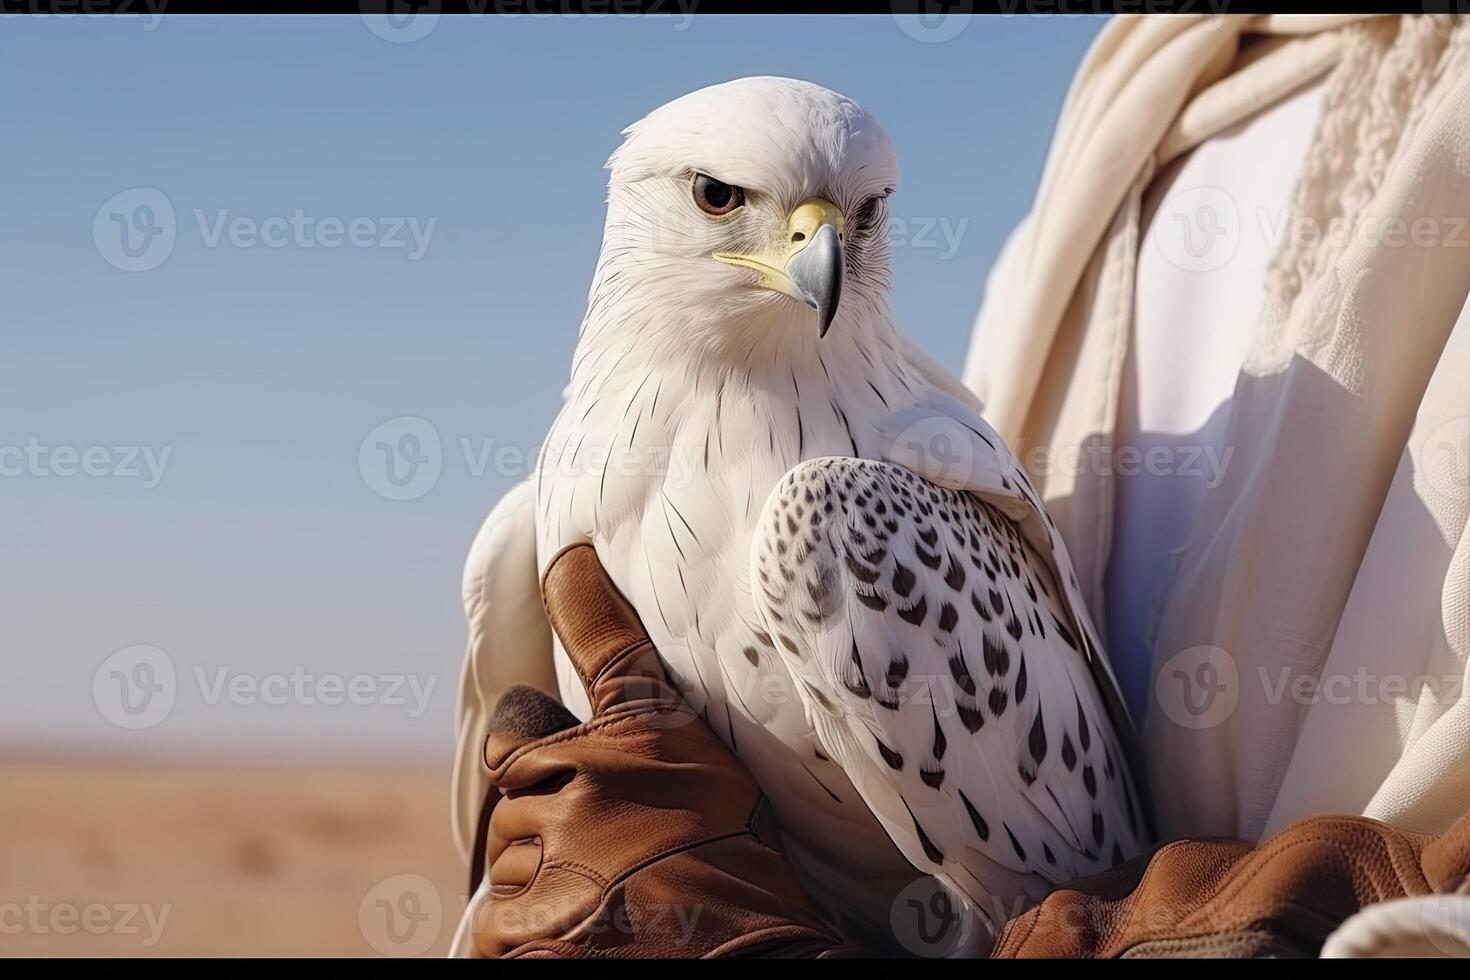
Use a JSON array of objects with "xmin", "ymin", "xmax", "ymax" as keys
[{"xmin": 459, "ymin": 78, "xmax": 1147, "ymax": 948}]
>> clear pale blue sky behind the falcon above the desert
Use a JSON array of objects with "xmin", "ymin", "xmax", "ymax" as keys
[{"xmin": 0, "ymin": 15, "xmax": 1101, "ymax": 758}]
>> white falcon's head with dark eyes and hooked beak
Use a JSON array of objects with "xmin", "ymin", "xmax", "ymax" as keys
[{"xmin": 601, "ymin": 78, "xmax": 898, "ymax": 350}]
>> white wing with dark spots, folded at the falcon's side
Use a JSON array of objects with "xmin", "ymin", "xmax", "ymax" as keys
[{"xmin": 753, "ymin": 457, "xmax": 1142, "ymax": 924}]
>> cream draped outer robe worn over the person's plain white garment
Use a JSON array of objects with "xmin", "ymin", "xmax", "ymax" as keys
[{"xmin": 964, "ymin": 9, "xmax": 1470, "ymax": 948}]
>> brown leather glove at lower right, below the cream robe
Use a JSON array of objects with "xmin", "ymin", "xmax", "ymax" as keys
[{"xmin": 991, "ymin": 814, "xmax": 1470, "ymax": 958}]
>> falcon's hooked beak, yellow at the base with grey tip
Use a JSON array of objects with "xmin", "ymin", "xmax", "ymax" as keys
[{"xmin": 714, "ymin": 197, "xmax": 845, "ymax": 336}]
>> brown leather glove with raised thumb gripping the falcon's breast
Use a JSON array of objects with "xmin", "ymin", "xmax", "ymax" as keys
[{"xmin": 472, "ymin": 545, "xmax": 845, "ymax": 958}]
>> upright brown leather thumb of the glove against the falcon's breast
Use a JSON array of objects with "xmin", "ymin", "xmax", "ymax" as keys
[{"xmin": 541, "ymin": 544, "xmax": 679, "ymax": 714}]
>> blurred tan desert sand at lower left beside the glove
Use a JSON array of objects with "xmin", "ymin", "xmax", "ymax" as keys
[{"xmin": 0, "ymin": 761, "xmax": 465, "ymax": 956}]
